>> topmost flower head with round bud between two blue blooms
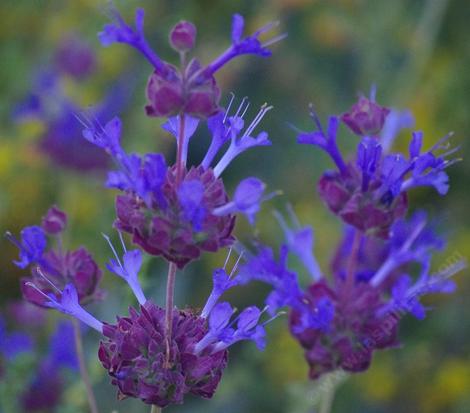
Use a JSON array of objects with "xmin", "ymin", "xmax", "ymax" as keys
[{"xmin": 98, "ymin": 9, "xmax": 284, "ymax": 119}]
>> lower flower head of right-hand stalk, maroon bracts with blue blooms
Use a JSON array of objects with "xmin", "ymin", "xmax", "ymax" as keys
[{"xmin": 240, "ymin": 208, "xmax": 465, "ymax": 379}]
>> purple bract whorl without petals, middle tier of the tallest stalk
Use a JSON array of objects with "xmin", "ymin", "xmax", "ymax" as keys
[{"xmin": 115, "ymin": 167, "xmax": 235, "ymax": 268}]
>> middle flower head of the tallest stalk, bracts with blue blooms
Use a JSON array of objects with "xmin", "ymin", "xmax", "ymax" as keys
[{"xmin": 82, "ymin": 98, "xmax": 275, "ymax": 268}]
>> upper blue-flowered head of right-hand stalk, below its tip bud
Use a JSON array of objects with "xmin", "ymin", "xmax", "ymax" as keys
[{"xmin": 298, "ymin": 104, "xmax": 455, "ymax": 238}]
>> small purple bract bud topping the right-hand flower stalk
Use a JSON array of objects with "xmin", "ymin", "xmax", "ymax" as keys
[{"xmin": 341, "ymin": 96, "xmax": 390, "ymax": 136}]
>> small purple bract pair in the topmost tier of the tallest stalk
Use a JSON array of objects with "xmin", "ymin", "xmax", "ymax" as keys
[{"xmin": 145, "ymin": 59, "xmax": 220, "ymax": 119}]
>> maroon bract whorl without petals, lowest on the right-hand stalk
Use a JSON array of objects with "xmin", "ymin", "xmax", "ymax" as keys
[{"xmin": 289, "ymin": 279, "xmax": 398, "ymax": 379}]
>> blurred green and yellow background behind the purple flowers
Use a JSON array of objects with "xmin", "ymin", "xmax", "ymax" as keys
[{"xmin": 0, "ymin": 0, "xmax": 470, "ymax": 413}]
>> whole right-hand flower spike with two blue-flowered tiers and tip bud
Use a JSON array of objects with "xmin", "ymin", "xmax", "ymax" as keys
[{"xmin": 240, "ymin": 90, "xmax": 465, "ymax": 379}]
